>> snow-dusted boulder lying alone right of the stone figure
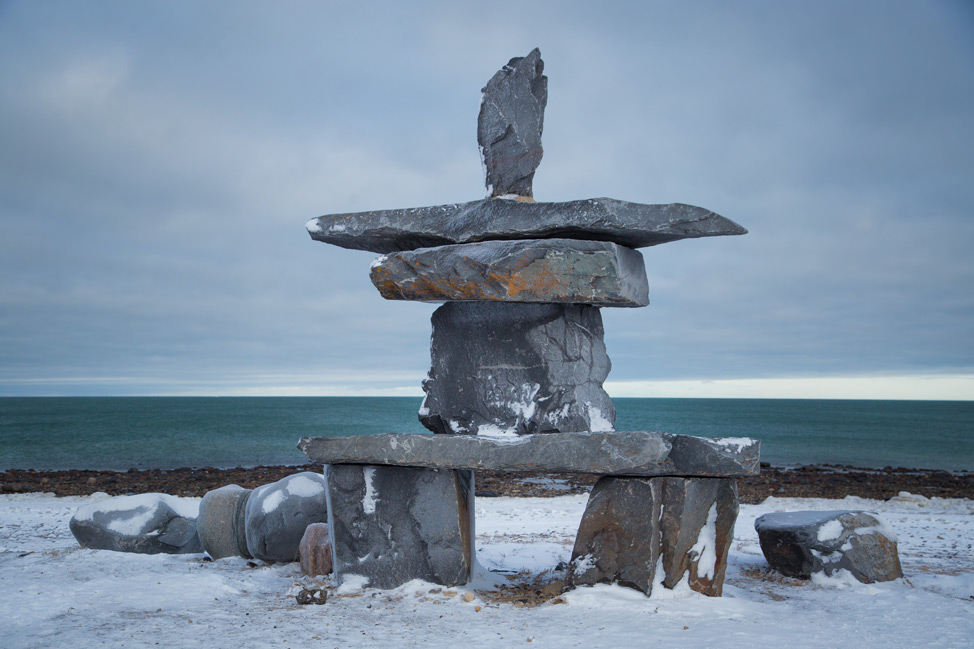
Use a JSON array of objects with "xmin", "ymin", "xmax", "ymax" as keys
[{"xmin": 754, "ymin": 511, "xmax": 903, "ymax": 583}]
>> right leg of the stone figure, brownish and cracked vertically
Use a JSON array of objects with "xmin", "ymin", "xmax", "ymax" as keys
[{"xmin": 565, "ymin": 477, "xmax": 739, "ymax": 597}]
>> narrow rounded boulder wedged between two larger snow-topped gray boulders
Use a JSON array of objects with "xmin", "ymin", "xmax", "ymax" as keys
[{"xmin": 197, "ymin": 485, "xmax": 253, "ymax": 559}]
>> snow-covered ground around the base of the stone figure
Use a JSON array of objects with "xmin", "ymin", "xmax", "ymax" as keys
[{"xmin": 0, "ymin": 494, "xmax": 974, "ymax": 649}]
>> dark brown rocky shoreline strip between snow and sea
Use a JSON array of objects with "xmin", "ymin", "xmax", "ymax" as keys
[{"xmin": 0, "ymin": 463, "xmax": 974, "ymax": 504}]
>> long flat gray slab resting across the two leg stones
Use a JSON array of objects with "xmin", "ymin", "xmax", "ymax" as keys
[{"xmin": 298, "ymin": 431, "xmax": 760, "ymax": 477}]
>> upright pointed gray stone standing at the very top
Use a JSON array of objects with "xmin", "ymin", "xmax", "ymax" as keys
[{"xmin": 477, "ymin": 48, "xmax": 548, "ymax": 196}]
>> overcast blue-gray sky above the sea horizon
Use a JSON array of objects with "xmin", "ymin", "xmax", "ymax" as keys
[{"xmin": 0, "ymin": 0, "xmax": 974, "ymax": 399}]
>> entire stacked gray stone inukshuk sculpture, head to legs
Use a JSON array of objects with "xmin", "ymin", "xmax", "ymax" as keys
[{"xmin": 301, "ymin": 49, "xmax": 758, "ymax": 594}]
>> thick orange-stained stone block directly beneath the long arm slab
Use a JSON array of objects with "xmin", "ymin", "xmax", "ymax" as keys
[{"xmin": 371, "ymin": 239, "xmax": 649, "ymax": 307}]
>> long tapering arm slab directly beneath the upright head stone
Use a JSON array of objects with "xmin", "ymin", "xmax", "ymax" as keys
[{"xmin": 305, "ymin": 198, "xmax": 747, "ymax": 253}]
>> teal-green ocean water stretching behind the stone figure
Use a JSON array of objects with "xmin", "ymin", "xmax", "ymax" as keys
[{"xmin": 0, "ymin": 397, "xmax": 974, "ymax": 471}]
